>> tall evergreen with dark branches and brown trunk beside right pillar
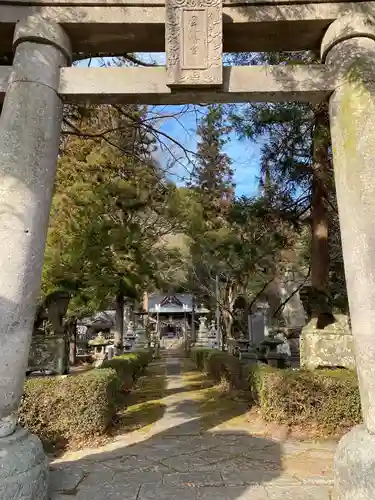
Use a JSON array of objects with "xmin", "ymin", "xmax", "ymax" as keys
[{"xmin": 228, "ymin": 52, "xmax": 346, "ymax": 327}]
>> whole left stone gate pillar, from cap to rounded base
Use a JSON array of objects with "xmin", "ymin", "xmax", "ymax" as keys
[{"xmin": 0, "ymin": 16, "xmax": 71, "ymax": 500}]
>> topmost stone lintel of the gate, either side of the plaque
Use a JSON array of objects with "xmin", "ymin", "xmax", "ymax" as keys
[{"xmin": 0, "ymin": 0, "xmax": 374, "ymax": 55}]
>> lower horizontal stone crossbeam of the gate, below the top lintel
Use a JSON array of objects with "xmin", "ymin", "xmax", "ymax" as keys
[{"xmin": 0, "ymin": 64, "xmax": 337, "ymax": 104}]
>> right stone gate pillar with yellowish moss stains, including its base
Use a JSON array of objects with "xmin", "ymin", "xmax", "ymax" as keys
[{"xmin": 322, "ymin": 15, "xmax": 375, "ymax": 500}]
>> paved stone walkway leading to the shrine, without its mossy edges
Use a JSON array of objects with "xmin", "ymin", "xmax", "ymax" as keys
[{"xmin": 51, "ymin": 358, "xmax": 335, "ymax": 500}]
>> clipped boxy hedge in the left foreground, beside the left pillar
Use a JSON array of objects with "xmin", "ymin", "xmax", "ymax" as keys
[{"xmin": 20, "ymin": 369, "xmax": 119, "ymax": 443}]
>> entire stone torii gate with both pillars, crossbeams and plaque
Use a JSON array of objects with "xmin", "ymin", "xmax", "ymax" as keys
[{"xmin": 0, "ymin": 0, "xmax": 375, "ymax": 500}]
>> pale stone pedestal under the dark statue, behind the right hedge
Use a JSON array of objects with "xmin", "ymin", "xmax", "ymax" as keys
[{"xmin": 300, "ymin": 315, "xmax": 355, "ymax": 370}]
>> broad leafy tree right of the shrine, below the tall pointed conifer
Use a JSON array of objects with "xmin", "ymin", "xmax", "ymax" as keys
[{"xmin": 188, "ymin": 189, "xmax": 295, "ymax": 335}]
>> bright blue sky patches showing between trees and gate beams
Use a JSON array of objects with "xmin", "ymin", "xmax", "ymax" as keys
[{"xmin": 78, "ymin": 53, "xmax": 260, "ymax": 196}]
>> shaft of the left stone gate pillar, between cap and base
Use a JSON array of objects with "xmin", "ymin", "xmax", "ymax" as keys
[{"xmin": 0, "ymin": 13, "xmax": 70, "ymax": 436}]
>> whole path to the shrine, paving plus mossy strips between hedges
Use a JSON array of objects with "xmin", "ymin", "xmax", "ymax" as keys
[{"xmin": 51, "ymin": 356, "xmax": 334, "ymax": 500}]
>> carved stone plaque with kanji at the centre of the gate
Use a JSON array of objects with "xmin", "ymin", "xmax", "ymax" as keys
[{"xmin": 165, "ymin": 0, "xmax": 223, "ymax": 88}]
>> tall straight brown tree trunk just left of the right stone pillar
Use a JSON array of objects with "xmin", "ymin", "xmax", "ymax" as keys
[{"xmin": 311, "ymin": 102, "xmax": 331, "ymax": 328}]
